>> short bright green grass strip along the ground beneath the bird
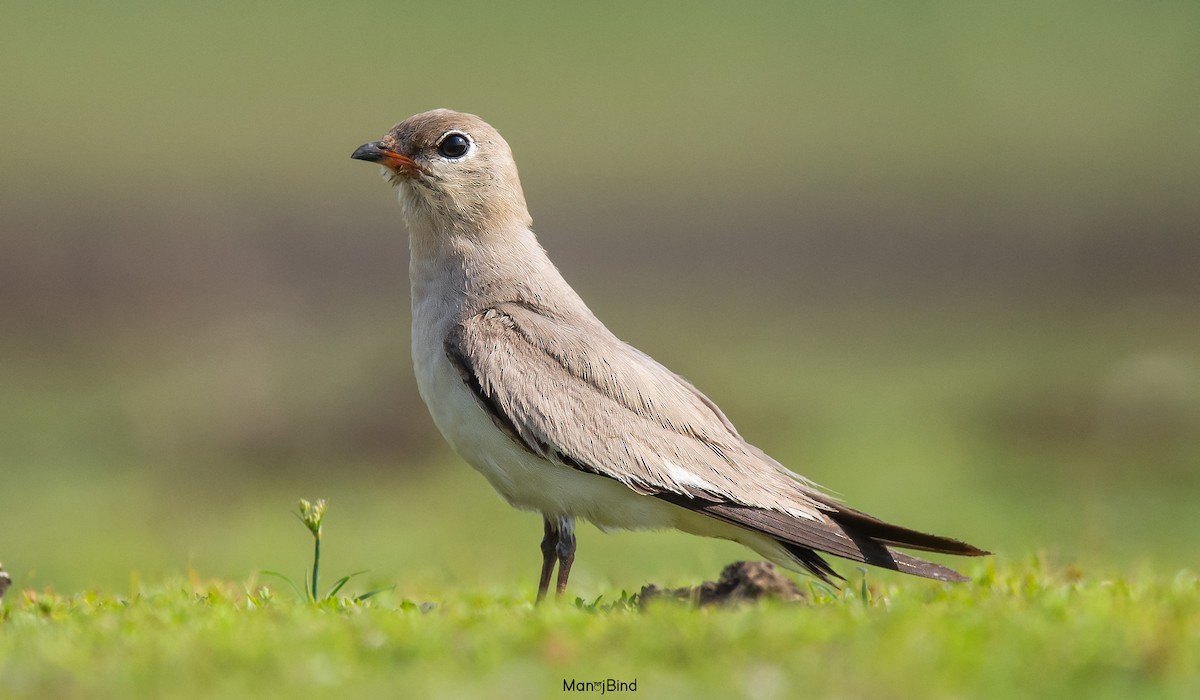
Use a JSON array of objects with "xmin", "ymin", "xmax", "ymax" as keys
[{"xmin": 0, "ymin": 560, "xmax": 1200, "ymax": 699}]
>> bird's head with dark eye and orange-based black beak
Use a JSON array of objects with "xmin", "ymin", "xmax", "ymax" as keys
[{"xmin": 350, "ymin": 109, "xmax": 530, "ymax": 232}]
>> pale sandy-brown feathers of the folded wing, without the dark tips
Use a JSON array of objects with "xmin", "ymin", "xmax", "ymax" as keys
[{"xmin": 446, "ymin": 303, "xmax": 827, "ymax": 509}]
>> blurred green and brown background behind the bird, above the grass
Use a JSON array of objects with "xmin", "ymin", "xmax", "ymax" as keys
[{"xmin": 0, "ymin": 0, "xmax": 1200, "ymax": 597}]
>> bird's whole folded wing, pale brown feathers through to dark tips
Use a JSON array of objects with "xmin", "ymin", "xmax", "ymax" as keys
[{"xmin": 445, "ymin": 303, "xmax": 988, "ymax": 581}]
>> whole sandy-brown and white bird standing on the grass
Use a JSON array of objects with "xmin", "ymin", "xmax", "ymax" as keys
[{"xmin": 350, "ymin": 109, "xmax": 989, "ymax": 600}]
